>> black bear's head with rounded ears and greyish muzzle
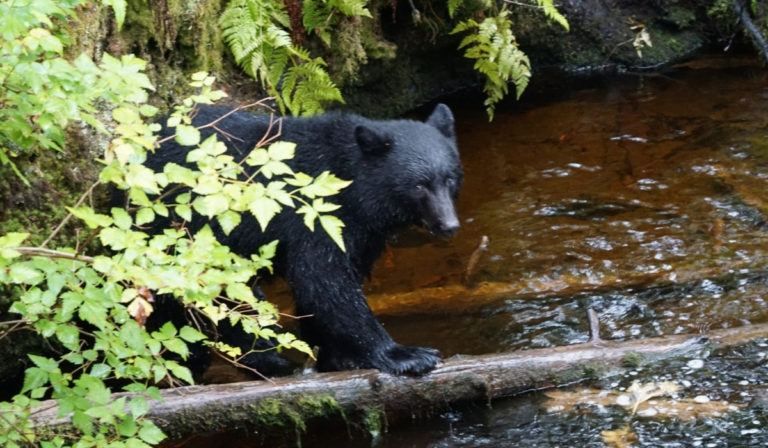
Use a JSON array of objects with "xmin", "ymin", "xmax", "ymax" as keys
[{"xmin": 355, "ymin": 104, "xmax": 463, "ymax": 237}]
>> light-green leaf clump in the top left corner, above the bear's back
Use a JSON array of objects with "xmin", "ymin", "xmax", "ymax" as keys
[{"xmin": 0, "ymin": 0, "xmax": 130, "ymax": 179}]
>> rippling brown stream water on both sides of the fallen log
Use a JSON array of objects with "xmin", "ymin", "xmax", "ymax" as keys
[{"xmin": 177, "ymin": 60, "xmax": 768, "ymax": 448}]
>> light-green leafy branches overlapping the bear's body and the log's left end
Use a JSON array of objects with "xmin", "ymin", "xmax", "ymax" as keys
[{"xmin": 0, "ymin": 73, "xmax": 349, "ymax": 447}]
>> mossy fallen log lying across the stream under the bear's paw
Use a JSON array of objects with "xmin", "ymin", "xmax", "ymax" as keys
[{"xmin": 33, "ymin": 324, "xmax": 768, "ymax": 439}]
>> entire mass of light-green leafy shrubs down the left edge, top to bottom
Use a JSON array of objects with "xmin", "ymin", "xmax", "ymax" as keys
[{"xmin": 0, "ymin": 0, "xmax": 349, "ymax": 448}]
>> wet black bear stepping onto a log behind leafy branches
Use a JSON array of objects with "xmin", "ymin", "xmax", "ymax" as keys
[{"xmin": 146, "ymin": 104, "xmax": 463, "ymax": 375}]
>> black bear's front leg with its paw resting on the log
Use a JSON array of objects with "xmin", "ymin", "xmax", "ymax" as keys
[{"xmin": 286, "ymin": 243, "xmax": 440, "ymax": 375}]
